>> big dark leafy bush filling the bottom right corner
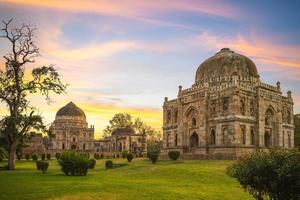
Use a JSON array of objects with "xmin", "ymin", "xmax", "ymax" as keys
[{"xmin": 227, "ymin": 150, "xmax": 300, "ymax": 200}]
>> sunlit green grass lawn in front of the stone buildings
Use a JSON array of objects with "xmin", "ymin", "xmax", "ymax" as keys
[{"xmin": 0, "ymin": 159, "xmax": 252, "ymax": 200}]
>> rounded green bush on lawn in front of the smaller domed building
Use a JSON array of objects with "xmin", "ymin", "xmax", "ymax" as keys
[{"xmin": 58, "ymin": 151, "xmax": 90, "ymax": 176}]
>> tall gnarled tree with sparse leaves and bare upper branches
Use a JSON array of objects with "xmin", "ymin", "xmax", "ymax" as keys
[{"xmin": 0, "ymin": 19, "xmax": 67, "ymax": 170}]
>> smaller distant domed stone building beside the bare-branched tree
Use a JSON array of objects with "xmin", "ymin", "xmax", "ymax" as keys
[{"xmin": 50, "ymin": 102, "xmax": 94, "ymax": 152}]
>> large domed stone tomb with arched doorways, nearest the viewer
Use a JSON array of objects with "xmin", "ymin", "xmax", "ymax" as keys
[{"xmin": 162, "ymin": 48, "xmax": 294, "ymax": 159}]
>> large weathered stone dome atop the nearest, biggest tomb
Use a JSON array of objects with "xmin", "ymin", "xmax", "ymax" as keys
[{"xmin": 195, "ymin": 48, "xmax": 259, "ymax": 82}]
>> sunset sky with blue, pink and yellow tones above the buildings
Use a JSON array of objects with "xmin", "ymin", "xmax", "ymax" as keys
[{"xmin": 0, "ymin": 0, "xmax": 300, "ymax": 138}]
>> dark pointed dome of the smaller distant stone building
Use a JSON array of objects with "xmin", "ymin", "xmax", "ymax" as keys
[{"xmin": 56, "ymin": 102, "xmax": 86, "ymax": 121}]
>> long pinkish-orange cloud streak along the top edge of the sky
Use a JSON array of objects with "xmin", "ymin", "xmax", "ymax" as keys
[{"xmin": 2, "ymin": 0, "xmax": 241, "ymax": 28}]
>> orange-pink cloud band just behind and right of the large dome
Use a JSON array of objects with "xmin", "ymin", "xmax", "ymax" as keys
[{"xmin": 197, "ymin": 32, "xmax": 300, "ymax": 68}]
